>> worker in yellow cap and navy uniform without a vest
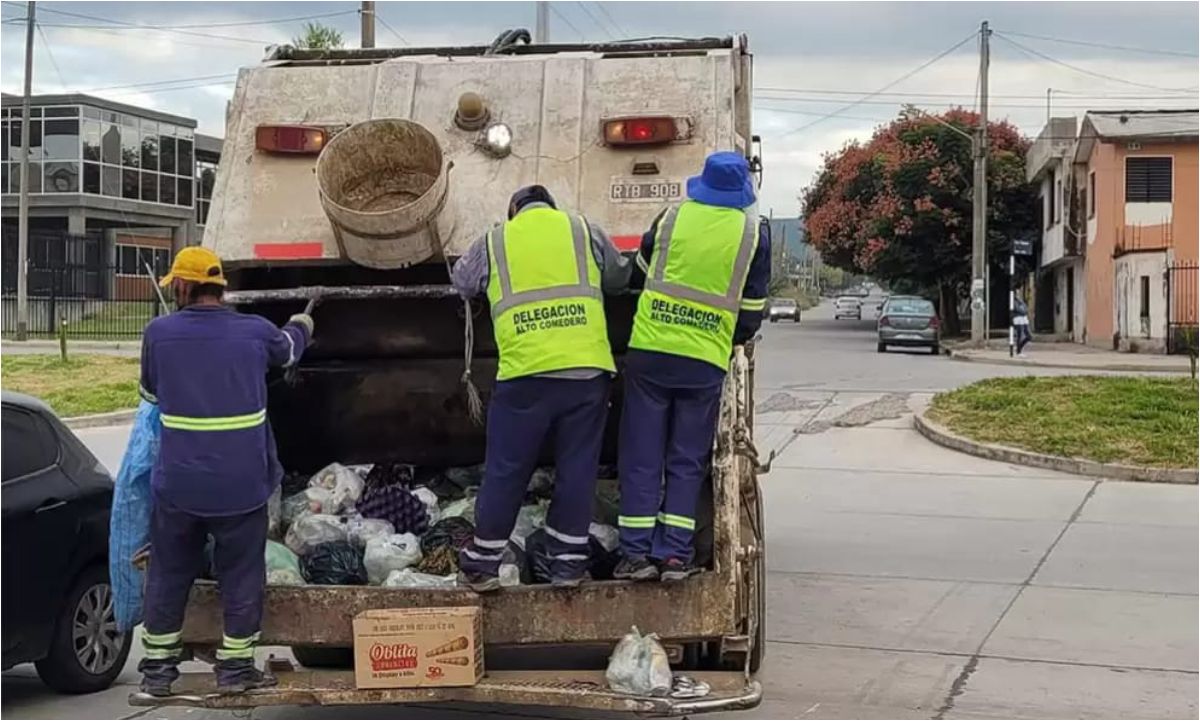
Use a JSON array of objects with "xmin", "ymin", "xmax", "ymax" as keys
[{"xmin": 138, "ymin": 247, "xmax": 313, "ymax": 697}]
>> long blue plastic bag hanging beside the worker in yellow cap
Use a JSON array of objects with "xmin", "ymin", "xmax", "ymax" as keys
[{"xmin": 108, "ymin": 401, "xmax": 162, "ymax": 631}]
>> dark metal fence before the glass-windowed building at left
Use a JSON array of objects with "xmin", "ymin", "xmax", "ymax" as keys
[{"xmin": 0, "ymin": 228, "xmax": 169, "ymax": 340}]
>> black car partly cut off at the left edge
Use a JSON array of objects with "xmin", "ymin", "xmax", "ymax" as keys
[{"xmin": 0, "ymin": 391, "xmax": 132, "ymax": 693}]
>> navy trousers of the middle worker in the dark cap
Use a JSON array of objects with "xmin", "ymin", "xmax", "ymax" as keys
[{"xmin": 458, "ymin": 374, "xmax": 610, "ymax": 578}]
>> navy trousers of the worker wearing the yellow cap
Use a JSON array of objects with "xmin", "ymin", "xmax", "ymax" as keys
[{"xmin": 144, "ymin": 499, "xmax": 266, "ymax": 659}]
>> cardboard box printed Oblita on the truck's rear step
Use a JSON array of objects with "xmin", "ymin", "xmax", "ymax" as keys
[{"xmin": 354, "ymin": 607, "xmax": 484, "ymax": 689}]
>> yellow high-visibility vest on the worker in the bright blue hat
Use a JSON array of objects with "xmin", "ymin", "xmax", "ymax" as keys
[{"xmin": 629, "ymin": 200, "xmax": 758, "ymax": 371}]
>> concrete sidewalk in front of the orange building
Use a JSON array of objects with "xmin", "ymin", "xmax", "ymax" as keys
[{"xmin": 949, "ymin": 342, "xmax": 1189, "ymax": 373}]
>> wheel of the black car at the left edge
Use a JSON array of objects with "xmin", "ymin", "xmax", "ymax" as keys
[{"xmin": 35, "ymin": 565, "xmax": 133, "ymax": 693}]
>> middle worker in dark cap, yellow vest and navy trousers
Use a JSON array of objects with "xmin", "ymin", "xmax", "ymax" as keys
[{"xmin": 452, "ymin": 185, "xmax": 629, "ymax": 593}]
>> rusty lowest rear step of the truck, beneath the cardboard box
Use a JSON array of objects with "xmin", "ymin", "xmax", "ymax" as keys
[{"xmin": 130, "ymin": 669, "xmax": 762, "ymax": 716}]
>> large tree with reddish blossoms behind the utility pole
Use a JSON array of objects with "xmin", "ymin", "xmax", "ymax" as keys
[{"xmin": 802, "ymin": 109, "xmax": 1040, "ymax": 334}]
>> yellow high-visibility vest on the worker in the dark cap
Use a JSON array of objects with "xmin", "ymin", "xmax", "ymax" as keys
[{"xmin": 487, "ymin": 208, "xmax": 616, "ymax": 380}]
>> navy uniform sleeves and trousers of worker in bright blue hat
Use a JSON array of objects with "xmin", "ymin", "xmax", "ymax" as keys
[{"xmin": 618, "ymin": 215, "xmax": 770, "ymax": 561}]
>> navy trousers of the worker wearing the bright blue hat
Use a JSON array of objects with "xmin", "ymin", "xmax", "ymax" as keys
[{"xmin": 617, "ymin": 361, "xmax": 722, "ymax": 561}]
